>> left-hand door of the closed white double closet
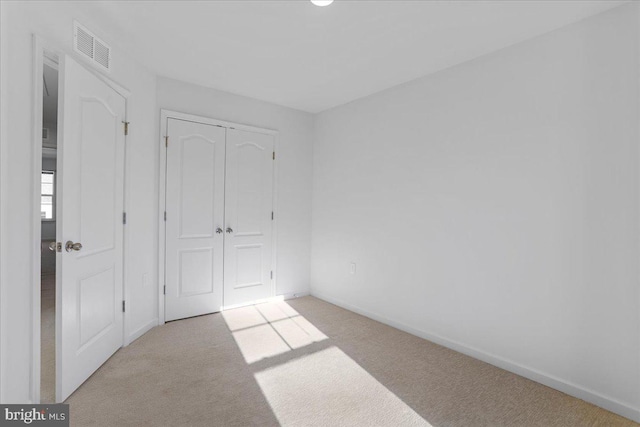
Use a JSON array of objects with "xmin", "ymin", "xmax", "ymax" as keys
[{"xmin": 165, "ymin": 118, "xmax": 225, "ymax": 321}]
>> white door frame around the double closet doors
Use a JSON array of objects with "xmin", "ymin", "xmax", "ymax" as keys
[{"xmin": 158, "ymin": 109, "xmax": 279, "ymax": 325}]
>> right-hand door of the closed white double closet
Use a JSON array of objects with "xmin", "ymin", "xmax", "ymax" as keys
[{"xmin": 224, "ymin": 129, "xmax": 274, "ymax": 307}]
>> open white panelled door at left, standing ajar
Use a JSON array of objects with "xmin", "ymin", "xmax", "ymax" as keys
[{"xmin": 56, "ymin": 56, "xmax": 126, "ymax": 402}]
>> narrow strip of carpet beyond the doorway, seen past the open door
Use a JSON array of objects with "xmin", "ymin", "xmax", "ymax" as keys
[{"xmin": 40, "ymin": 272, "xmax": 56, "ymax": 403}]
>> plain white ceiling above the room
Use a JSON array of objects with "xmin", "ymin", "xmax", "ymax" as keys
[{"xmin": 76, "ymin": 0, "xmax": 625, "ymax": 113}]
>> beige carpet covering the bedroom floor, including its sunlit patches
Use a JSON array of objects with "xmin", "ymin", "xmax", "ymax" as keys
[{"xmin": 68, "ymin": 297, "xmax": 638, "ymax": 427}]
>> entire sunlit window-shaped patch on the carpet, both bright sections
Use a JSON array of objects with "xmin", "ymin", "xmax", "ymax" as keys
[{"xmin": 222, "ymin": 301, "xmax": 431, "ymax": 427}]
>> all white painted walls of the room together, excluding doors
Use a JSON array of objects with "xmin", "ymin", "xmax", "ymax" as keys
[{"xmin": 0, "ymin": 2, "xmax": 640, "ymax": 420}]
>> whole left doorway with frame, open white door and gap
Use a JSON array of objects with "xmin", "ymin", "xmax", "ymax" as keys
[{"xmin": 32, "ymin": 37, "xmax": 129, "ymax": 403}]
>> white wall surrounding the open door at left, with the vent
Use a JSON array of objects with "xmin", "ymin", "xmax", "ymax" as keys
[{"xmin": 0, "ymin": 2, "xmax": 158, "ymax": 403}]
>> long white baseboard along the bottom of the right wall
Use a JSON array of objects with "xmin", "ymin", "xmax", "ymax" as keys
[{"xmin": 311, "ymin": 289, "xmax": 640, "ymax": 422}]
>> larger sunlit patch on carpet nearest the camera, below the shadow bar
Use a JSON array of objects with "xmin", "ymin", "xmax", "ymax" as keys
[{"xmin": 254, "ymin": 347, "xmax": 431, "ymax": 426}]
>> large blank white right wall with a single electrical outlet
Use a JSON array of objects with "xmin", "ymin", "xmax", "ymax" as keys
[{"xmin": 312, "ymin": 4, "xmax": 640, "ymax": 421}]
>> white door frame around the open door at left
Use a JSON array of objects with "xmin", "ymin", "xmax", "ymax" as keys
[{"xmin": 29, "ymin": 34, "xmax": 131, "ymax": 404}]
